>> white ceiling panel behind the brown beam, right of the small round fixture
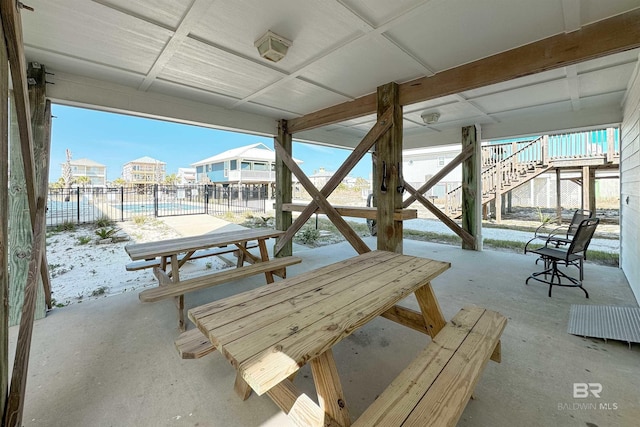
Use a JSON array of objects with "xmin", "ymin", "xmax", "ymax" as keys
[{"xmin": 473, "ymin": 80, "xmax": 570, "ymax": 114}]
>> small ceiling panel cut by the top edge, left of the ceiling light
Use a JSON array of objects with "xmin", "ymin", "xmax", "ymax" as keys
[{"xmin": 94, "ymin": 0, "xmax": 194, "ymax": 28}]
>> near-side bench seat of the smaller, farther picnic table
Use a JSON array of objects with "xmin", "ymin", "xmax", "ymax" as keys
[{"xmin": 138, "ymin": 256, "xmax": 302, "ymax": 302}]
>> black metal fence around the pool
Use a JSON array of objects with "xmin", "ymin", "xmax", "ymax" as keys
[{"xmin": 47, "ymin": 184, "xmax": 268, "ymax": 226}]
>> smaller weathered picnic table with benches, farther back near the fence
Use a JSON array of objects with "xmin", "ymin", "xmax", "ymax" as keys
[{"xmin": 125, "ymin": 229, "xmax": 300, "ymax": 330}]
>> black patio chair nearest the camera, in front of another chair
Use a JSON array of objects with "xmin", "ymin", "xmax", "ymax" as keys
[{"xmin": 525, "ymin": 218, "xmax": 600, "ymax": 298}]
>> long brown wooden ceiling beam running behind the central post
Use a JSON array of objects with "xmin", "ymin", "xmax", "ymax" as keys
[{"xmin": 289, "ymin": 8, "xmax": 640, "ymax": 133}]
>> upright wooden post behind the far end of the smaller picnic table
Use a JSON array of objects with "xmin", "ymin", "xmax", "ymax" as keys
[{"xmin": 274, "ymin": 120, "xmax": 293, "ymax": 257}]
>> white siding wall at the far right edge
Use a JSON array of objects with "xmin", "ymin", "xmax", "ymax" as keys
[{"xmin": 620, "ymin": 65, "xmax": 640, "ymax": 303}]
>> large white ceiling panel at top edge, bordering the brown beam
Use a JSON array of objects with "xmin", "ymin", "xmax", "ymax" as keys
[{"xmin": 388, "ymin": 0, "xmax": 564, "ymax": 71}]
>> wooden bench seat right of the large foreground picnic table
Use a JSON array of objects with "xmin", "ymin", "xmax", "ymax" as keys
[{"xmin": 353, "ymin": 307, "xmax": 506, "ymax": 427}]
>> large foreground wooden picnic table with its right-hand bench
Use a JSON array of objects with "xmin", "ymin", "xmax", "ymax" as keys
[{"xmin": 186, "ymin": 251, "xmax": 506, "ymax": 427}]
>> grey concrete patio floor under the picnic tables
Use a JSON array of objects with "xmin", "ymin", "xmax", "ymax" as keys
[{"xmin": 10, "ymin": 238, "xmax": 640, "ymax": 427}]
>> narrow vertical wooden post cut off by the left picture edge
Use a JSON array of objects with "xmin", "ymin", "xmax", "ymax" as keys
[{"xmin": 0, "ymin": 15, "xmax": 9, "ymax": 424}]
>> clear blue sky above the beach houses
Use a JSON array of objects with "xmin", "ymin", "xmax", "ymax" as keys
[{"xmin": 49, "ymin": 104, "xmax": 371, "ymax": 182}]
